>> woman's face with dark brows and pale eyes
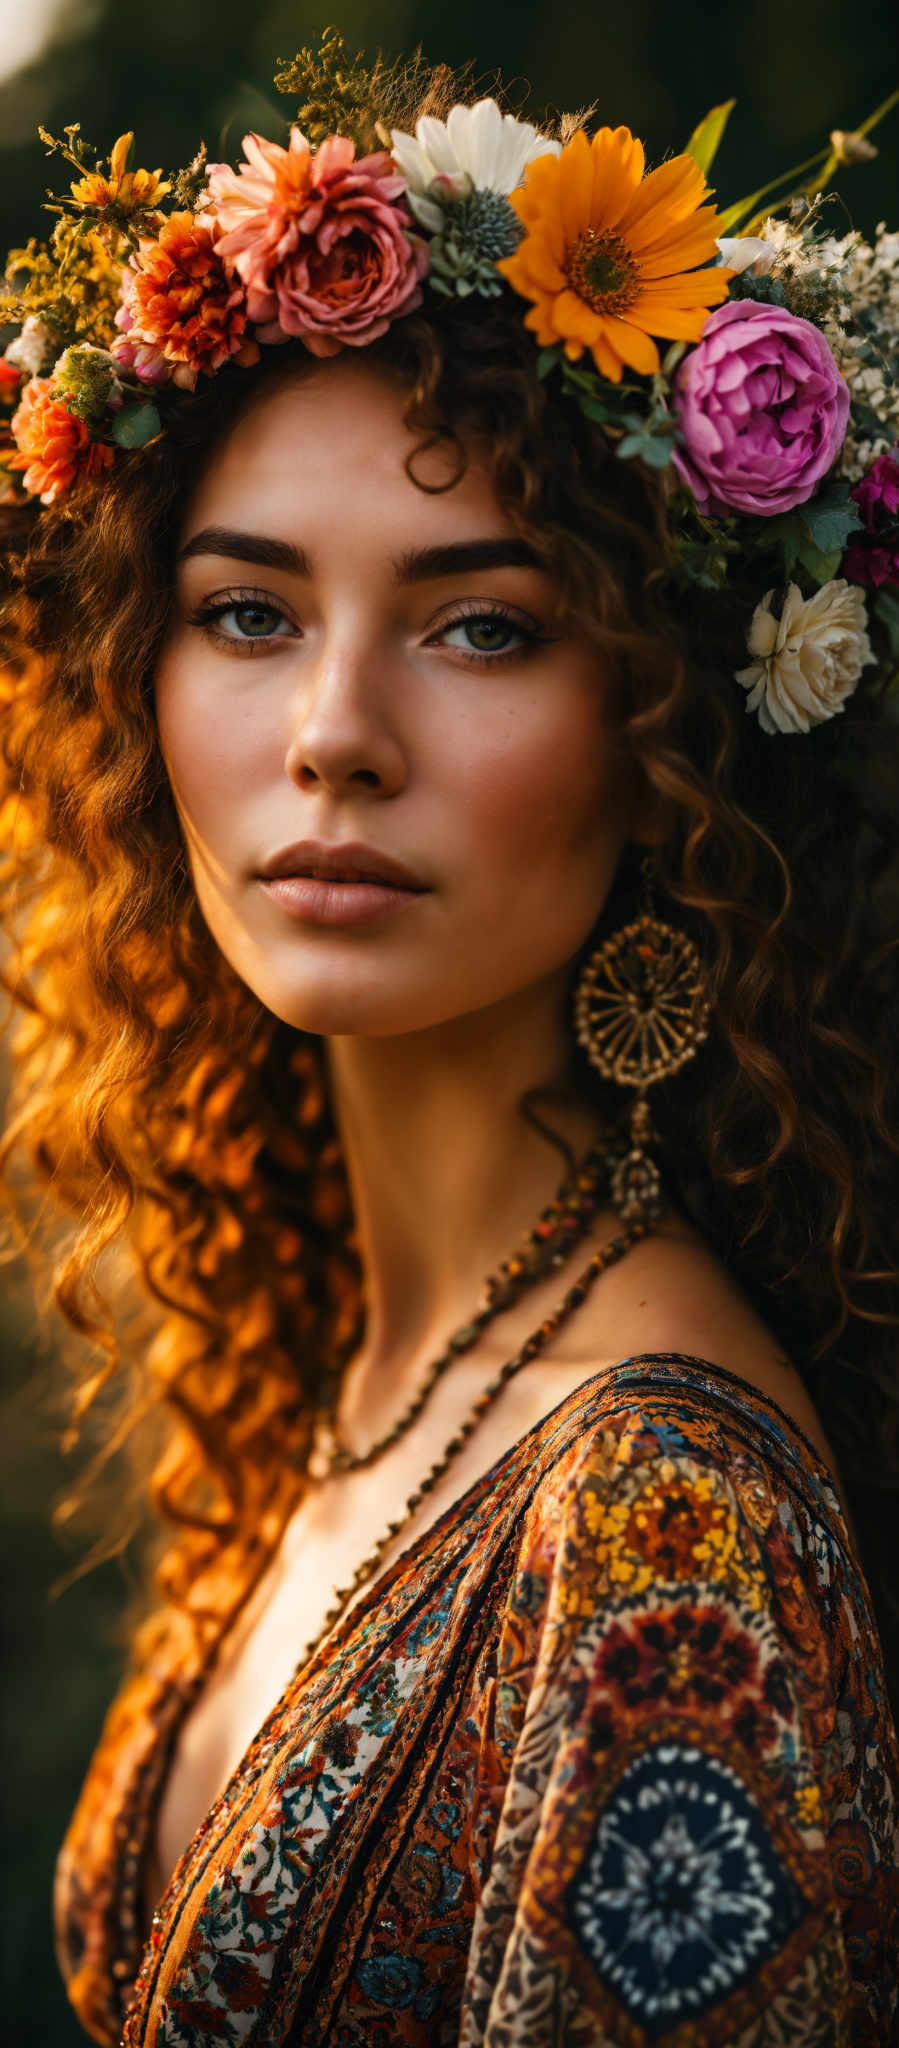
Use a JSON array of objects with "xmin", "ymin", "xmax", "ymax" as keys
[{"xmin": 156, "ymin": 360, "xmax": 647, "ymax": 1036}]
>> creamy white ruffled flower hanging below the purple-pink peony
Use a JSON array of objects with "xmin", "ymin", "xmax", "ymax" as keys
[{"xmin": 737, "ymin": 575, "xmax": 876, "ymax": 733}]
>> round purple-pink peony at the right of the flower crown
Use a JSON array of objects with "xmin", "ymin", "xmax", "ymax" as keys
[{"xmin": 672, "ymin": 299, "xmax": 850, "ymax": 518}]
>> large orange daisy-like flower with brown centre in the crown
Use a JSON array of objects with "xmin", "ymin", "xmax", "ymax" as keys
[{"xmin": 498, "ymin": 127, "xmax": 733, "ymax": 383}]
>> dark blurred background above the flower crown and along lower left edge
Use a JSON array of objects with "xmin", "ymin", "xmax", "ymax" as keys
[{"xmin": 0, "ymin": 0, "xmax": 899, "ymax": 2048}]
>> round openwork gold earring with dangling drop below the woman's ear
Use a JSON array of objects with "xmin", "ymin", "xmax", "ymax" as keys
[{"xmin": 573, "ymin": 862, "xmax": 711, "ymax": 1223}]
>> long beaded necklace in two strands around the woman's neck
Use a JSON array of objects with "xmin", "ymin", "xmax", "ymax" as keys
[{"xmin": 293, "ymin": 1147, "xmax": 657, "ymax": 1679}]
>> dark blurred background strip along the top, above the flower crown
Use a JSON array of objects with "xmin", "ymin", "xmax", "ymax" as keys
[{"xmin": 0, "ymin": 0, "xmax": 899, "ymax": 250}]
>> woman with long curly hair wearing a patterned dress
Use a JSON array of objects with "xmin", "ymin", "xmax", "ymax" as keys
[{"xmin": 4, "ymin": 44, "xmax": 899, "ymax": 2048}]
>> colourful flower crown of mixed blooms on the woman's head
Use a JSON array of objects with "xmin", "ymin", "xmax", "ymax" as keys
[{"xmin": 0, "ymin": 31, "xmax": 899, "ymax": 733}]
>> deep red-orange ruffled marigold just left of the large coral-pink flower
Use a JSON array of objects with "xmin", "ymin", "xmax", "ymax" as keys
[{"xmin": 113, "ymin": 213, "xmax": 258, "ymax": 391}]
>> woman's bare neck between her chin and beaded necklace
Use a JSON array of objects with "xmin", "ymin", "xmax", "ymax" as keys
[{"xmin": 319, "ymin": 991, "xmax": 610, "ymax": 1366}]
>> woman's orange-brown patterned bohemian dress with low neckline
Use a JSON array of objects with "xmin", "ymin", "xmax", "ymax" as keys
[{"xmin": 55, "ymin": 1354, "xmax": 899, "ymax": 2048}]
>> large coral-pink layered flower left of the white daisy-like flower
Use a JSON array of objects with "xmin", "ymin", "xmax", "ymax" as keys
[{"xmin": 209, "ymin": 127, "xmax": 428, "ymax": 356}]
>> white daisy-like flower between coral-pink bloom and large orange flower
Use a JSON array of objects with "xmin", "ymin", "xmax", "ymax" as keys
[{"xmin": 391, "ymin": 100, "xmax": 561, "ymax": 233}]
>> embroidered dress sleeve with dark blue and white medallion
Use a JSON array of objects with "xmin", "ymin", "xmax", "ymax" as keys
[{"xmin": 459, "ymin": 1405, "xmax": 899, "ymax": 2048}]
